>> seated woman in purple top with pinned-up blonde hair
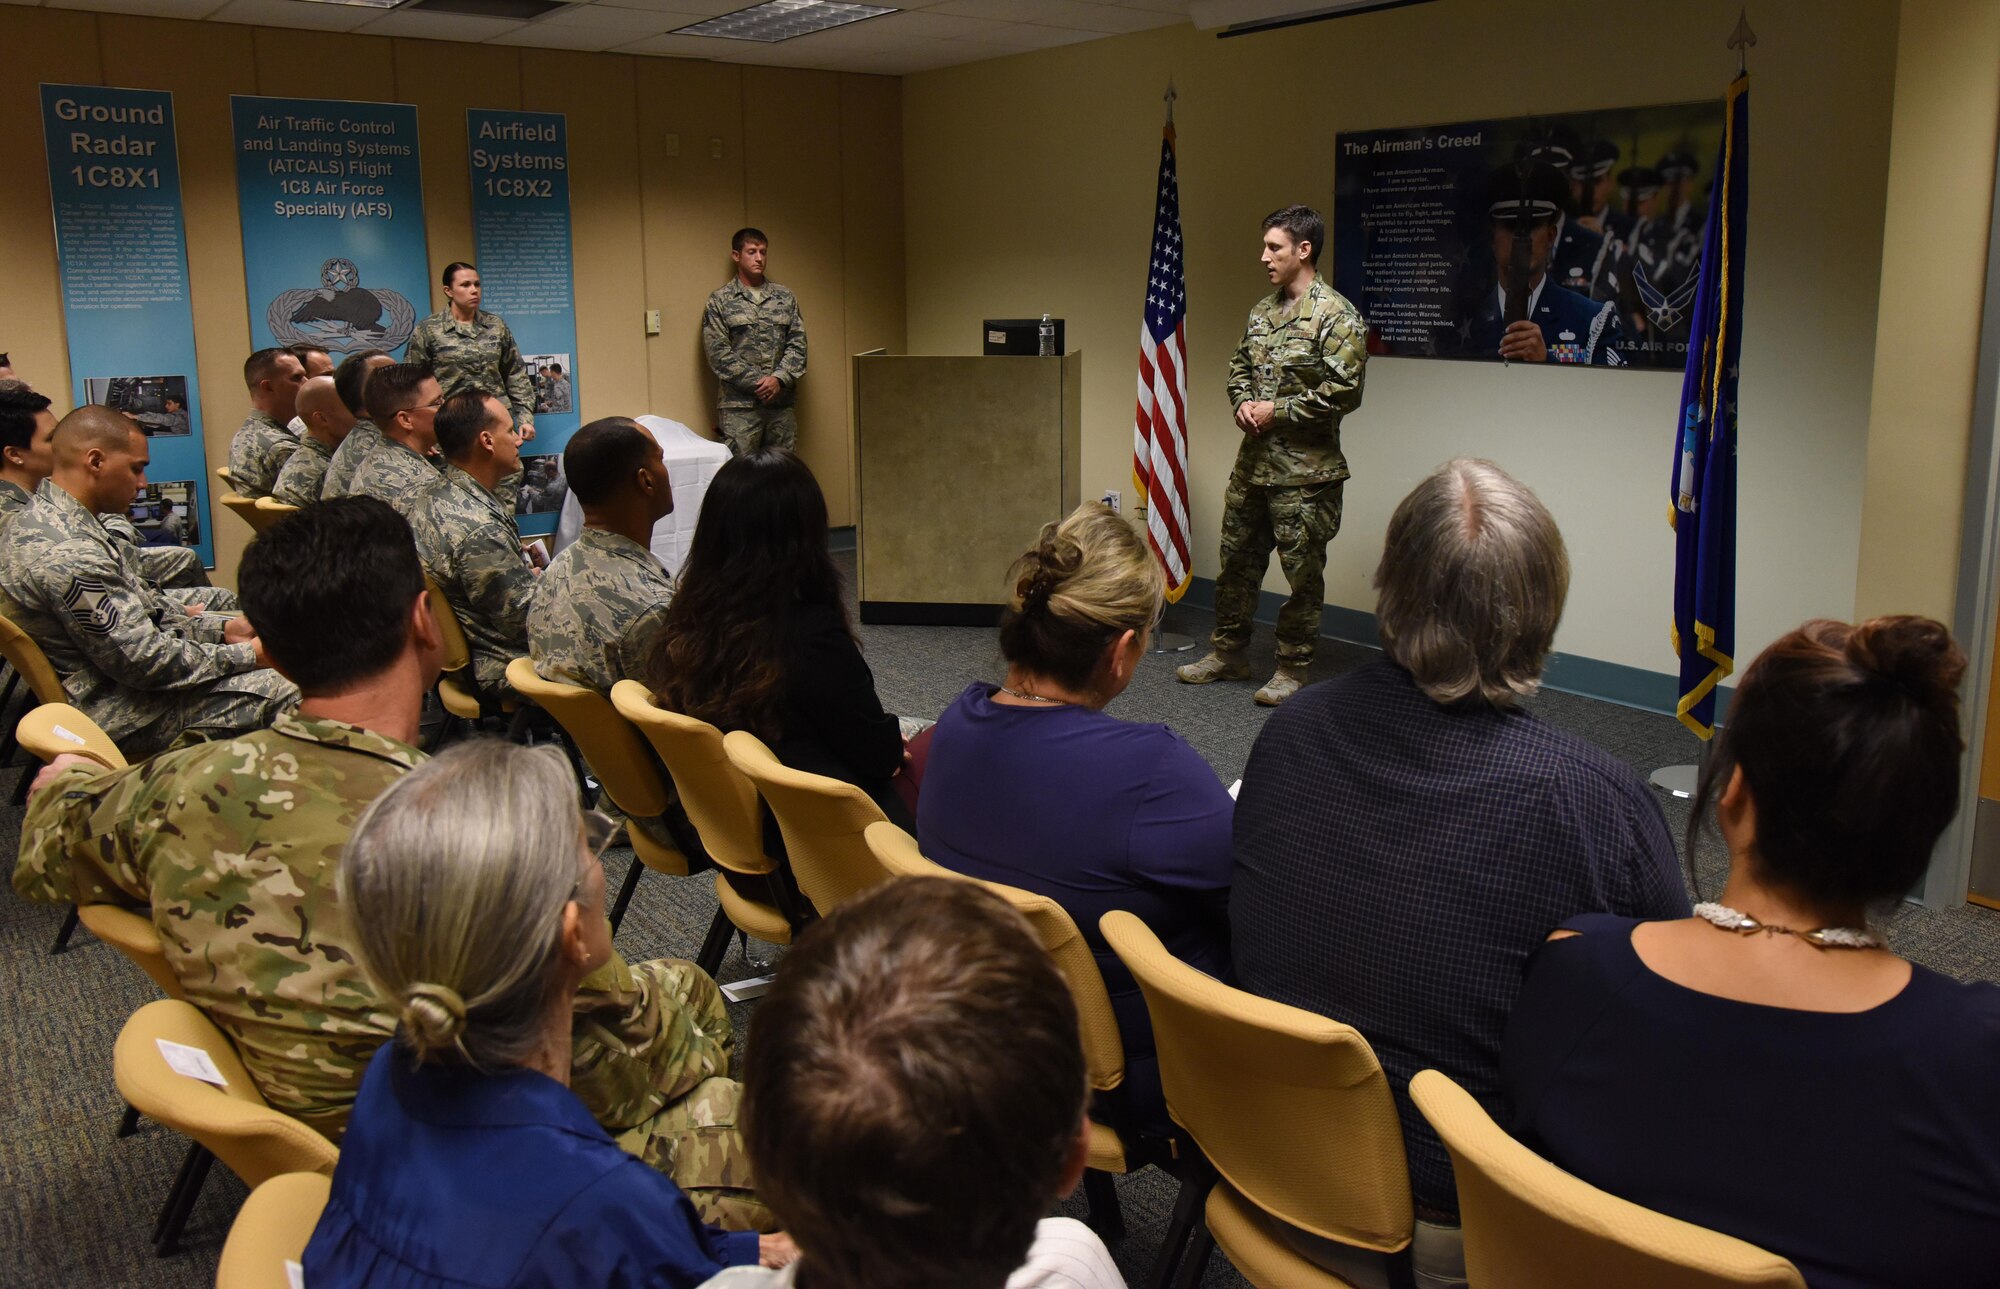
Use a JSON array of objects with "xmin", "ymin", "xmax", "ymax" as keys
[{"xmin": 916, "ymin": 502, "xmax": 1234, "ymax": 1131}]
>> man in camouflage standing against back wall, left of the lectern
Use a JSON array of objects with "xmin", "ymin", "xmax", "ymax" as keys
[{"xmin": 702, "ymin": 228, "xmax": 806, "ymax": 456}]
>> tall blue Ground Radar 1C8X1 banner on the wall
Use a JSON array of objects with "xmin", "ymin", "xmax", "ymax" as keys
[{"xmin": 39, "ymin": 84, "xmax": 216, "ymax": 566}]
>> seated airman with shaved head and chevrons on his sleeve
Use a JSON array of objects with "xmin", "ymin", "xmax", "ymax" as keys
[{"xmin": 0, "ymin": 406, "xmax": 298, "ymax": 761}]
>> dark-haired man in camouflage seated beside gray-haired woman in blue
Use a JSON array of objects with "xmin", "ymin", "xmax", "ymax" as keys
[{"xmin": 14, "ymin": 496, "xmax": 770, "ymax": 1229}]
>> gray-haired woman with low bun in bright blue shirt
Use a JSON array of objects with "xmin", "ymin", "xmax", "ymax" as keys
[{"xmin": 302, "ymin": 741, "xmax": 792, "ymax": 1289}]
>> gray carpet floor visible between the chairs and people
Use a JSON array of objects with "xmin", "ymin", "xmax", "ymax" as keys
[{"xmin": 0, "ymin": 554, "xmax": 2000, "ymax": 1287}]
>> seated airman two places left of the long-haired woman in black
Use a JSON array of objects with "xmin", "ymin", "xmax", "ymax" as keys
[{"xmin": 410, "ymin": 390, "xmax": 534, "ymax": 705}]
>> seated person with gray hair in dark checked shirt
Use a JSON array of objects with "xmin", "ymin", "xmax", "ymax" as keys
[{"xmin": 1230, "ymin": 458, "xmax": 1688, "ymax": 1289}]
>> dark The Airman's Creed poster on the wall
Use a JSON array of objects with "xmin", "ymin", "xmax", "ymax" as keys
[{"xmin": 1334, "ymin": 100, "xmax": 1722, "ymax": 370}]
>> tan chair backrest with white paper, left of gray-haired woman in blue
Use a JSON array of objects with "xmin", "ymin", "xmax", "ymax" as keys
[{"xmin": 112, "ymin": 999, "xmax": 340, "ymax": 1187}]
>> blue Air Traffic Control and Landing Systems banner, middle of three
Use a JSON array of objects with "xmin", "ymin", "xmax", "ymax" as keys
[{"xmin": 230, "ymin": 94, "xmax": 430, "ymax": 362}]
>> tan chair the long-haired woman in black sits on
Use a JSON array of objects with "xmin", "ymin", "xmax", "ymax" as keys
[{"xmin": 612, "ymin": 681, "xmax": 806, "ymax": 963}]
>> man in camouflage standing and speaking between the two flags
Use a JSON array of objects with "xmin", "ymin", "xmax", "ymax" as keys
[{"xmin": 1174, "ymin": 206, "xmax": 1368, "ymax": 707}]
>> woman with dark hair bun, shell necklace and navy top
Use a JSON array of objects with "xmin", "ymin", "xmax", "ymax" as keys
[{"xmin": 1502, "ymin": 616, "xmax": 2000, "ymax": 1289}]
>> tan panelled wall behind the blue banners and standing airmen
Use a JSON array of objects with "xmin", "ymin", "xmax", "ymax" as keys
[{"xmin": 0, "ymin": 6, "xmax": 904, "ymax": 580}]
